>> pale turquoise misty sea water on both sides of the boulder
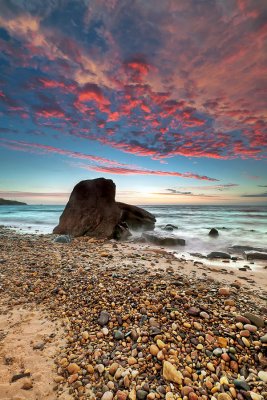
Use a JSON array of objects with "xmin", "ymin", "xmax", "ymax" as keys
[{"xmin": 0, "ymin": 205, "xmax": 267, "ymax": 254}]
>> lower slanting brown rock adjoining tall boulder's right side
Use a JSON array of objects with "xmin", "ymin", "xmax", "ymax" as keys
[{"xmin": 116, "ymin": 202, "xmax": 156, "ymax": 231}]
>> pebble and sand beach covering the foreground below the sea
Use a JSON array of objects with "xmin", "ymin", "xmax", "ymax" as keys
[{"xmin": 0, "ymin": 228, "xmax": 267, "ymax": 400}]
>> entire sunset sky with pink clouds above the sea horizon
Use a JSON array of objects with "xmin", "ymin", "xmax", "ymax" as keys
[{"xmin": 0, "ymin": 0, "xmax": 267, "ymax": 204}]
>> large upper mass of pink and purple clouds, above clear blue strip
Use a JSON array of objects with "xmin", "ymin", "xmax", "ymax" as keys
[{"xmin": 0, "ymin": 0, "xmax": 267, "ymax": 164}]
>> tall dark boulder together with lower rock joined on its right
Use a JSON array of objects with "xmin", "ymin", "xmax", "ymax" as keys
[{"xmin": 53, "ymin": 178, "xmax": 156, "ymax": 240}]
